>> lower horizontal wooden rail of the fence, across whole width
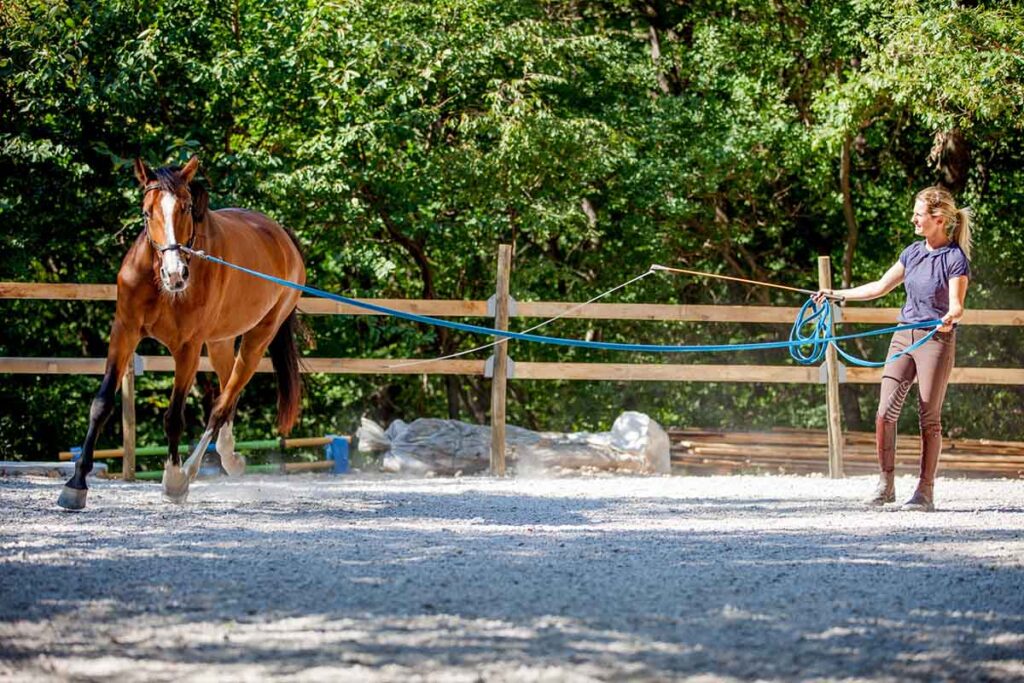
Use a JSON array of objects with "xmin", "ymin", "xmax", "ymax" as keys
[{"xmin": 0, "ymin": 355, "xmax": 1024, "ymax": 385}]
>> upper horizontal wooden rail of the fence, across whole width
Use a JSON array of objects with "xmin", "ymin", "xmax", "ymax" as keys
[{"xmin": 0, "ymin": 283, "xmax": 1024, "ymax": 327}]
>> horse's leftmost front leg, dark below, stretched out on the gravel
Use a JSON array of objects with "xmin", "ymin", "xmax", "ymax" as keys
[{"xmin": 57, "ymin": 319, "xmax": 141, "ymax": 510}]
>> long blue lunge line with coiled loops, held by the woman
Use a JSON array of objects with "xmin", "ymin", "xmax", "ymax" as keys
[{"xmin": 181, "ymin": 247, "xmax": 942, "ymax": 366}]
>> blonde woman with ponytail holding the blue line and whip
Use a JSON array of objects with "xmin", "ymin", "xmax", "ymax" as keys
[{"xmin": 815, "ymin": 187, "xmax": 971, "ymax": 512}]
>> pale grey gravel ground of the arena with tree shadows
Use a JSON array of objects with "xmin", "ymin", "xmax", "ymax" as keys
[{"xmin": 0, "ymin": 475, "xmax": 1024, "ymax": 681}]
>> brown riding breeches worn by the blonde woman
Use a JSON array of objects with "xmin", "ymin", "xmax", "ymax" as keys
[{"xmin": 874, "ymin": 330, "xmax": 956, "ymax": 484}]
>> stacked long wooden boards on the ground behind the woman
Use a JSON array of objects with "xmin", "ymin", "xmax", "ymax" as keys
[{"xmin": 669, "ymin": 429, "xmax": 1024, "ymax": 478}]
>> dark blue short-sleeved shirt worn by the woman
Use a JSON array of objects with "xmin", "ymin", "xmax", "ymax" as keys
[{"xmin": 899, "ymin": 240, "xmax": 971, "ymax": 323}]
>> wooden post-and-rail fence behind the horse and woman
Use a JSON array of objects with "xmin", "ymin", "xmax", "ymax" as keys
[{"xmin": 0, "ymin": 246, "xmax": 1024, "ymax": 477}]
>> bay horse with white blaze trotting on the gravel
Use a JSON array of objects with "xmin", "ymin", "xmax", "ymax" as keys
[{"xmin": 57, "ymin": 157, "xmax": 306, "ymax": 510}]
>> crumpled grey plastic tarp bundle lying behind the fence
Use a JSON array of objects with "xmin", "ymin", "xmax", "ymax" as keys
[{"xmin": 355, "ymin": 412, "xmax": 669, "ymax": 474}]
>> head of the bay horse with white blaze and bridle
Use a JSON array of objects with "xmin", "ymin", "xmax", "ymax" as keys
[{"xmin": 135, "ymin": 157, "xmax": 209, "ymax": 293}]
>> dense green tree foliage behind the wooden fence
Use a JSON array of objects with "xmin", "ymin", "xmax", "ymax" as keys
[{"xmin": 0, "ymin": 0, "xmax": 1024, "ymax": 457}]
